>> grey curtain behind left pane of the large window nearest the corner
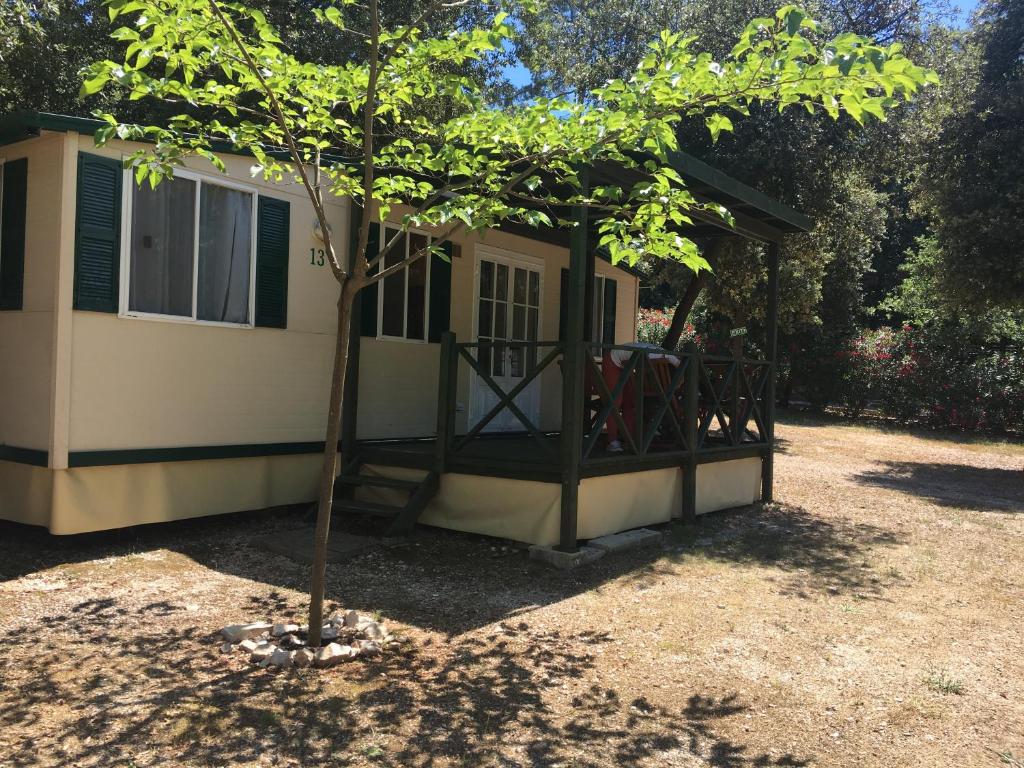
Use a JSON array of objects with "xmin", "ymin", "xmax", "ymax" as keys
[{"xmin": 128, "ymin": 179, "xmax": 196, "ymax": 317}]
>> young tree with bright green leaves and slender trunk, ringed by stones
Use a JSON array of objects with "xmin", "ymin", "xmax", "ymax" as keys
[{"xmin": 83, "ymin": 0, "xmax": 933, "ymax": 646}]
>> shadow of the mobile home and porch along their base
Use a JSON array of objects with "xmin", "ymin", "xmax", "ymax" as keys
[{"xmin": 0, "ymin": 493, "xmax": 900, "ymax": 638}]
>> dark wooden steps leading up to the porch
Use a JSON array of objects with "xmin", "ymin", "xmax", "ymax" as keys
[{"xmin": 332, "ymin": 452, "xmax": 440, "ymax": 537}]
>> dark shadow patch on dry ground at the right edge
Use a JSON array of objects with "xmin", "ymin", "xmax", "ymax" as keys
[{"xmin": 854, "ymin": 461, "xmax": 1024, "ymax": 512}]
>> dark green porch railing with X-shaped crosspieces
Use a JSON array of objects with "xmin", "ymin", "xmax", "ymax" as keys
[{"xmin": 437, "ymin": 334, "xmax": 771, "ymax": 471}]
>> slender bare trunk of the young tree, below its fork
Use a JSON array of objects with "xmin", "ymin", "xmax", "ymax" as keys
[{"xmin": 308, "ymin": 280, "xmax": 355, "ymax": 648}]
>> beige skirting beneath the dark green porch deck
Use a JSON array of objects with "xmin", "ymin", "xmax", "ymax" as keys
[{"xmin": 357, "ymin": 459, "xmax": 761, "ymax": 545}]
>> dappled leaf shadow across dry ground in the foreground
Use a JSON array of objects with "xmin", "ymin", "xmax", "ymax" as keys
[{"xmin": 0, "ymin": 598, "xmax": 808, "ymax": 768}]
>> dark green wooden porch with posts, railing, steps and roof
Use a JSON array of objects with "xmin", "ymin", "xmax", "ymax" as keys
[{"xmin": 331, "ymin": 151, "xmax": 810, "ymax": 551}]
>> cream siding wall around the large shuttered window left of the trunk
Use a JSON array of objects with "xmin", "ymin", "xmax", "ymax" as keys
[{"xmin": 70, "ymin": 137, "xmax": 349, "ymax": 451}]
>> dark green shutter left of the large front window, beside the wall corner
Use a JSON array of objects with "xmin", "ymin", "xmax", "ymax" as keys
[{"xmin": 72, "ymin": 153, "xmax": 124, "ymax": 312}]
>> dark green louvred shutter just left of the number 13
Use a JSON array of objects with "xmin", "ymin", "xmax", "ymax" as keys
[{"xmin": 255, "ymin": 195, "xmax": 292, "ymax": 328}]
